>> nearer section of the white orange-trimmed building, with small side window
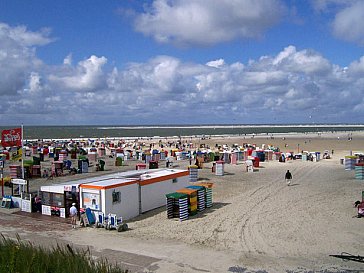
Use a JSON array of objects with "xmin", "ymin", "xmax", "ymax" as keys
[{"xmin": 80, "ymin": 177, "xmax": 139, "ymax": 220}]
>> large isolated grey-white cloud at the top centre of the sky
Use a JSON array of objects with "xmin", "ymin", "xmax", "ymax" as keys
[{"xmin": 135, "ymin": 0, "xmax": 284, "ymax": 46}]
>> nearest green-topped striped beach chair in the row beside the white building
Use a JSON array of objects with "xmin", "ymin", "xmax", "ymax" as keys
[{"xmin": 166, "ymin": 192, "xmax": 188, "ymax": 221}]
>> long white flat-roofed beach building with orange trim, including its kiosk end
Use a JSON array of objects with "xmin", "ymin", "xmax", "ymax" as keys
[{"xmin": 41, "ymin": 169, "xmax": 190, "ymax": 220}]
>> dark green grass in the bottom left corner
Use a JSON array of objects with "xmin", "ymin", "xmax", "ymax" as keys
[{"xmin": 0, "ymin": 235, "xmax": 128, "ymax": 273}]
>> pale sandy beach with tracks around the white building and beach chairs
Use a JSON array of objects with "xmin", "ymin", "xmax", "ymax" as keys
[{"xmin": 0, "ymin": 132, "xmax": 364, "ymax": 272}]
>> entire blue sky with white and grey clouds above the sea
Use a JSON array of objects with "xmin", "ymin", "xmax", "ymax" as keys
[{"xmin": 0, "ymin": 0, "xmax": 364, "ymax": 126}]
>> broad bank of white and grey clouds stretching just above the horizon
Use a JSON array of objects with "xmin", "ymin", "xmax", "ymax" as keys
[{"xmin": 0, "ymin": 21, "xmax": 364, "ymax": 124}]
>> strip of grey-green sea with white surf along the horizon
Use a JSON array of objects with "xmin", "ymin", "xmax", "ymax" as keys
[{"xmin": 0, "ymin": 124, "xmax": 364, "ymax": 140}]
